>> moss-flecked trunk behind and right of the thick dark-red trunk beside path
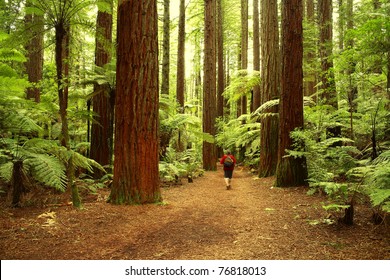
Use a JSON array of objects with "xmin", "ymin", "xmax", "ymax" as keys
[{"xmin": 318, "ymin": 0, "xmax": 341, "ymax": 137}]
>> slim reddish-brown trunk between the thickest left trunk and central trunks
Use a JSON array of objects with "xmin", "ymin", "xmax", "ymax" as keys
[{"xmin": 176, "ymin": 0, "xmax": 186, "ymax": 112}]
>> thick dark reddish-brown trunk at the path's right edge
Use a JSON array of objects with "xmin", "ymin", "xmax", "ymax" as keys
[{"xmin": 275, "ymin": 0, "xmax": 307, "ymax": 187}]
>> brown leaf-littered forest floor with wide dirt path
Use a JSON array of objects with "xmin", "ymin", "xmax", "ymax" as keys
[{"xmin": 0, "ymin": 167, "xmax": 390, "ymax": 260}]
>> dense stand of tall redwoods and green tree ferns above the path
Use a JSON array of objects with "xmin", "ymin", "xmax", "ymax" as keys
[{"xmin": 0, "ymin": 0, "xmax": 390, "ymax": 224}]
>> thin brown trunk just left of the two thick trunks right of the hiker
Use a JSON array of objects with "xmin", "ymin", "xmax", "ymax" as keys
[{"xmin": 251, "ymin": 0, "xmax": 263, "ymax": 112}]
